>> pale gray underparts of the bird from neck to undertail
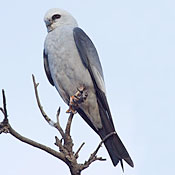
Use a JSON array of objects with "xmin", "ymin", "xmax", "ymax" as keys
[{"xmin": 44, "ymin": 25, "xmax": 102, "ymax": 129}]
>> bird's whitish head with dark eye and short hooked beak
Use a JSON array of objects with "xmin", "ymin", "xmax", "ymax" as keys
[{"xmin": 44, "ymin": 8, "xmax": 77, "ymax": 32}]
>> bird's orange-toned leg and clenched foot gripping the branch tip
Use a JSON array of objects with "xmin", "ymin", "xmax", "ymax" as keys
[{"xmin": 66, "ymin": 85, "xmax": 88, "ymax": 114}]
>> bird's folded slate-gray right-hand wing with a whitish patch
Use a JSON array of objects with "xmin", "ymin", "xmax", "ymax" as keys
[{"xmin": 73, "ymin": 27, "xmax": 114, "ymax": 129}]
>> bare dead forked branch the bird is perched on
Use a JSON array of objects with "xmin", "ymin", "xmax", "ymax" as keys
[{"xmin": 0, "ymin": 75, "xmax": 107, "ymax": 175}]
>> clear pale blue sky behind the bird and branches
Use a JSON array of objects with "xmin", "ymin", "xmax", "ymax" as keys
[{"xmin": 0, "ymin": 0, "xmax": 175, "ymax": 175}]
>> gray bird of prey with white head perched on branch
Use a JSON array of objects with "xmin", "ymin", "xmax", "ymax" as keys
[{"xmin": 43, "ymin": 8, "xmax": 134, "ymax": 168}]
